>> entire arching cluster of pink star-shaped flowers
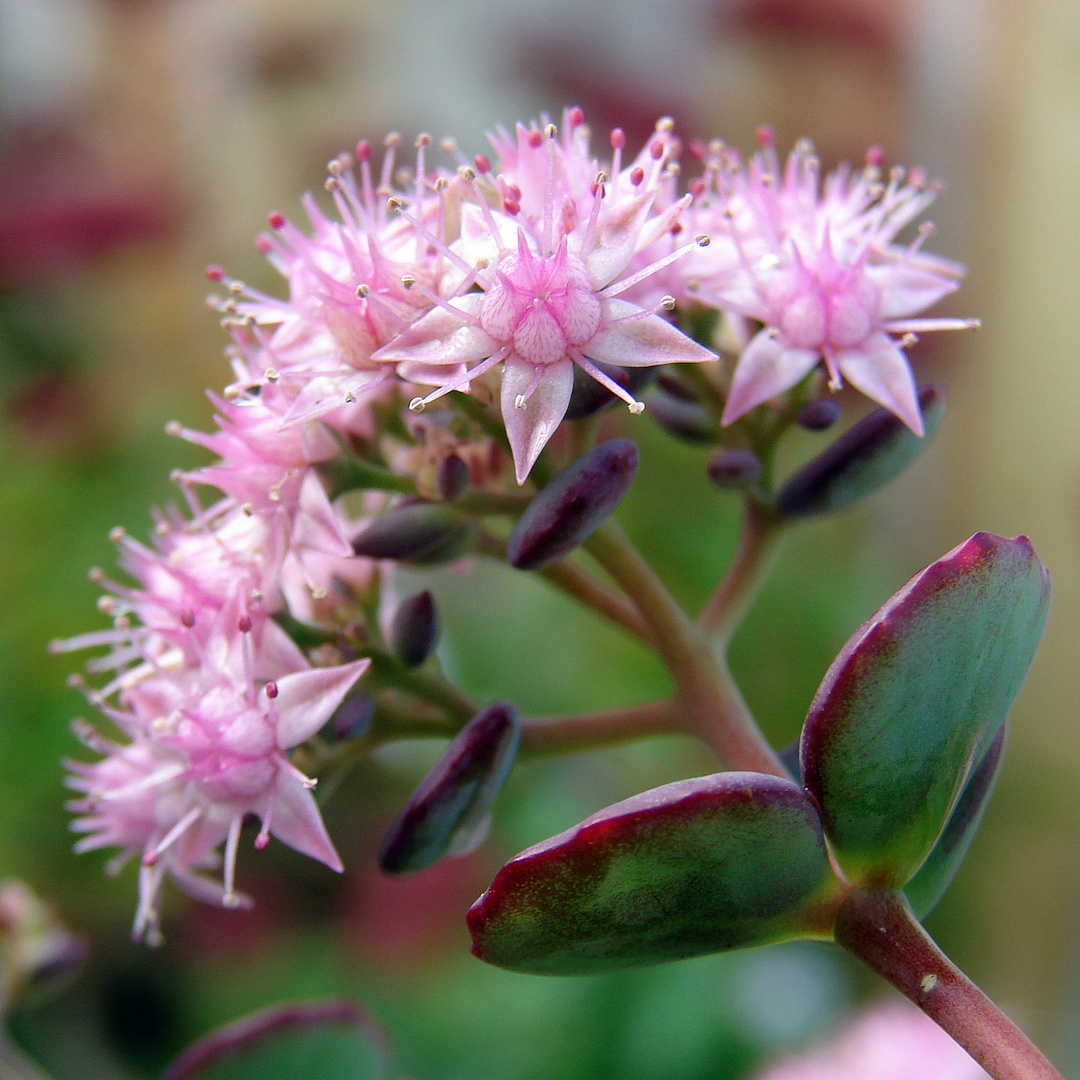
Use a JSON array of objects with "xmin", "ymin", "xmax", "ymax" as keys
[{"xmin": 56, "ymin": 108, "xmax": 968, "ymax": 939}]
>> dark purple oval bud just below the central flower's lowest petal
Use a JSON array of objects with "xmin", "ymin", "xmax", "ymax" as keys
[{"xmin": 507, "ymin": 438, "xmax": 637, "ymax": 570}]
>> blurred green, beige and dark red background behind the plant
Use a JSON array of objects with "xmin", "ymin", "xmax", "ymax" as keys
[{"xmin": 0, "ymin": 0, "xmax": 1080, "ymax": 1080}]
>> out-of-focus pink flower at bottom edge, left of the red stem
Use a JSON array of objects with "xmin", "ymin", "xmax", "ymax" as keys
[{"xmin": 758, "ymin": 1001, "xmax": 987, "ymax": 1080}]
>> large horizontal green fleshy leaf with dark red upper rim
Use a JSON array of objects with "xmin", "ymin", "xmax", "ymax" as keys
[{"xmin": 469, "ymin": 772, "xmax": 833, "ymax": 975}]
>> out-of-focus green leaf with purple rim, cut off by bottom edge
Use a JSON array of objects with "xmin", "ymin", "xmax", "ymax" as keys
[{"xmin": 161, "ymin": 1000, "xmax": 390, "ymax": 1080}]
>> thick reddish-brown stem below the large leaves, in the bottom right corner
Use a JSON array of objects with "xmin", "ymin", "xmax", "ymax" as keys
[{"xmin": 835, "ymin": 888, "xmax": 1062, "ymax": 1080}]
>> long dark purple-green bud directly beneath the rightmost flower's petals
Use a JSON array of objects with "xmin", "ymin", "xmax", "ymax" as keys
[{"xmin": 777, "ymin": 386, "xmax": 945, "ymax": 517}]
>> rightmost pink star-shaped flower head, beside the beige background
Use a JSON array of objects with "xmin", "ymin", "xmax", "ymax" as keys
[{"xmin": 671, "ymin": 131, "xmax": 977, "ymax": 435}]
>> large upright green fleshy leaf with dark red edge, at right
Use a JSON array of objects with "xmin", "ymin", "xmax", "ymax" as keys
[{"xmin": 800, "ymin": 532, "xmax": 1050, "ymax": 888}]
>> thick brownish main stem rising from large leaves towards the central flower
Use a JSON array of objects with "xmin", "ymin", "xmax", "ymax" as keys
[{"xmin": 584, "ymin": 519, "xmax": 788, "ymax": 778}]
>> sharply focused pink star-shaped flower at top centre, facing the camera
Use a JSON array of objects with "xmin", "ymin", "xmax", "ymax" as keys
[{"xmin": 373, "ymin": 110, "xmax": 716, "ymax": 484}]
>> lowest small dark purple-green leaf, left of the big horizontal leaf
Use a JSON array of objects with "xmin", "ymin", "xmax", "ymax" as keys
[{"xmin": 379, "ymin": 702, "xmax": 521, "ymax": 874}]
